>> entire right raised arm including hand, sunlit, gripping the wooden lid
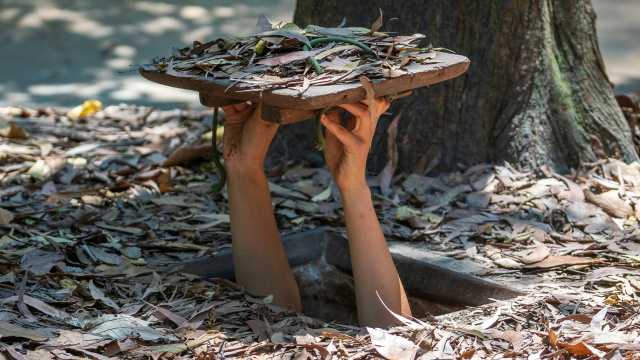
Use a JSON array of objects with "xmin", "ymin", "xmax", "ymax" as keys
[{"xmin": 322, "ymin": 98, "xmax": 411, "ymax": 326}]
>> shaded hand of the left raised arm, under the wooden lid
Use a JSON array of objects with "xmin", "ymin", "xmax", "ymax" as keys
[{"xmin": 222, "ymin": 103, "xmax": 278, "ymax": 171}]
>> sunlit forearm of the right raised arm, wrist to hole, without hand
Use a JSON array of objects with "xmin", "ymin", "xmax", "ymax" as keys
[{"xmin": 340, "ymin": 184, "xmax": 410, "ymax": 326}]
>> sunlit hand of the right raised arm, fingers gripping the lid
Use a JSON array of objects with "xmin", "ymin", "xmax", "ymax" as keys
[{"xmin": 321, "ymin": 97, "xmax": 389, "ymax": 191}]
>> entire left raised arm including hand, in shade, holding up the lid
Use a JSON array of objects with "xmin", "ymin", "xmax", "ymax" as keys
[{"xmin": 222, "ymin": 103, "xmax": 302, "ymax": 311}]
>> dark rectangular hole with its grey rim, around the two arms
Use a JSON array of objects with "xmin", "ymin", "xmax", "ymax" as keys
[{"xmin": 174, "ymin": 228, "xmax": 523, "ymax": 325}]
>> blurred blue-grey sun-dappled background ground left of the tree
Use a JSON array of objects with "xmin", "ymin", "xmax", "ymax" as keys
[{"xmin": 0, "ymin": 0, "xmax": 295, "ymax": 109}]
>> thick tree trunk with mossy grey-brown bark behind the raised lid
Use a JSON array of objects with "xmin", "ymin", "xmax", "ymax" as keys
[{"xmin": 283, "ymin": 0, "xmax": 637, "ymax": 172}]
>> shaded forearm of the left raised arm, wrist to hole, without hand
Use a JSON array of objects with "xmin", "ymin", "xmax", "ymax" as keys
[{"xmin": 227, "ymin": 166, "xmax": 301, "ymax": 311}]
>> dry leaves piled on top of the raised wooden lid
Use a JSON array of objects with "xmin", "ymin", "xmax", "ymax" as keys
[{"xmin": 142, "ymin": 11, "xmax": 443, "ymax": 94}]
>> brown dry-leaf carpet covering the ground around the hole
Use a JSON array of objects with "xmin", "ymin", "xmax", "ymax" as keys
[{"xmin": 0, "ymin": 105, "xmax": 640, "ymax": 360}]
